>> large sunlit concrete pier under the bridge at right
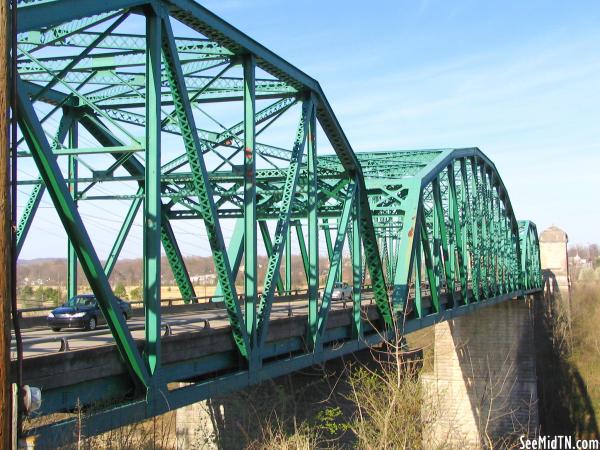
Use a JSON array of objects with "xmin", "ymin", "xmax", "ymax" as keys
[{"xmin": 423, "ymin": 299, "xmax": 539, "ymax": 449}]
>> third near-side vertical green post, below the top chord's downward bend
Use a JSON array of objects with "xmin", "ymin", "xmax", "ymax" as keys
[{"xmin": 308, "ymin": 103, "xmax": 319, "ymax": 343}]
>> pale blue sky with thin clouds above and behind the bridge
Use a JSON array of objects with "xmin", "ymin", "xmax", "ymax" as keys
[{"xmin": 19, "ymin": 0, "xmax": 600, "ymax": 259}]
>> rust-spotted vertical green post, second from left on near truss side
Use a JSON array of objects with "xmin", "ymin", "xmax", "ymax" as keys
[{"xmin": 242, "ymin": 55, "xmax": 258, "ymax": 352}]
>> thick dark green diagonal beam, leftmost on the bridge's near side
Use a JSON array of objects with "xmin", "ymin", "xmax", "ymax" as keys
[{"xmin": 17, "ymin": 79, "xmax": 150, "ymax": 386}]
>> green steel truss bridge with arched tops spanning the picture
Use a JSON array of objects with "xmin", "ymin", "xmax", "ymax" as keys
[{"xmin": 11, "ymin": 0, "xmax": 541, "ymax": 442}]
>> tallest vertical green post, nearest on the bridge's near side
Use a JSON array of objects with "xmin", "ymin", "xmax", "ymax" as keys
[{"xmin": 142, "ymin": 9, "xmax": 162, "ymax": 374}]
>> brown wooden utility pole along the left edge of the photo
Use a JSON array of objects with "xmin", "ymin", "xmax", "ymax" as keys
[{"xmin": 0, "ymin": 0, "xmax": 12, "ymax": 449}]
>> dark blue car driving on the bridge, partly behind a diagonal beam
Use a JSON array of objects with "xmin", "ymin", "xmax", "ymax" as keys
[{"xmin": 48, "ymin": 294, "xmax": 131, "ymax": 331}]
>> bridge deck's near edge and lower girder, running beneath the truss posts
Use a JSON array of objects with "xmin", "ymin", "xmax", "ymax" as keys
[{"xmin": 15, "ymin": 289, "xmax": 537, "ymax": 444}]
